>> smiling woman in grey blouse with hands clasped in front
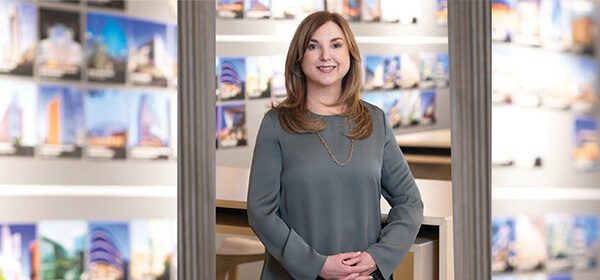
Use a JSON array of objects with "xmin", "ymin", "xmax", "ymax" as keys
[{"xmin": 248, "ymin": 11, "xmax": 423, "ymax": 280}]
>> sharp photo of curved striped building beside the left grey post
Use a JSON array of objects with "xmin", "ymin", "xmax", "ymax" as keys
[{"xmin": 218, "ymin": 57, "xmax": 246, "ymax": 100}]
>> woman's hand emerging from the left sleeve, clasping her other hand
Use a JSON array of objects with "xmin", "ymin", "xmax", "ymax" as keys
[{"xmin": 319, "ymin": 252, "xmax": 373, "ymax": 280}]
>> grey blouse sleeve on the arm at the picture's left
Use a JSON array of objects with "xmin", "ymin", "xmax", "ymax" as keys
[{"xmin": 247, "ymin": 112, "xmax": 327, "ymax": 280}]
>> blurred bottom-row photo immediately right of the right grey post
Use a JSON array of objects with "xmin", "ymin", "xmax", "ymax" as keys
[{"xmin": 491, "ymin": 216, "xmax": 516, "ymax": 272}]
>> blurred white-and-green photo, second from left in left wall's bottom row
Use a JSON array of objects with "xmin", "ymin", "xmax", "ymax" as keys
[{"xmin": 38, "ymin": 220, "xmax": 88, "ymax": 280}]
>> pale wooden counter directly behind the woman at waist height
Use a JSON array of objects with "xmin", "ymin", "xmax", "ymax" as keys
[{"xmin": 216, "ymin": 166, "xmax": 454, "ymax": 280}]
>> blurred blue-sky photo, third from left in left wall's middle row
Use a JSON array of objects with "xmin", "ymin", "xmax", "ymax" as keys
[{"xmin": 84, "ymin": 89, "xmax": 129, "ymax": 159}]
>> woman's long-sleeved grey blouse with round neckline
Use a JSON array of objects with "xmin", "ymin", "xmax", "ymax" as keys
[{"xmin": 248, "ymin": 103, "xmax": 423, "ymax": 280}]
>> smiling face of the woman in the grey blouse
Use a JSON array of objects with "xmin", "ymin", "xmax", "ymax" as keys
[{"xmin": 302, "ymin": 21, "xmax": 350, "ymax": 92}]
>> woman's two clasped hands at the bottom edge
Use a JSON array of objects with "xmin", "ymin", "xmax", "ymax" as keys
[{"xmin": 319, "ymin": 252, "xmax": 377, "ymax": 280}]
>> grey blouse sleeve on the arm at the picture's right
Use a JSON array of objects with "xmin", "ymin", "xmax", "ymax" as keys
[{"xmin": 366, "ymin": 111, "xmax": 423, "ymax": 279}]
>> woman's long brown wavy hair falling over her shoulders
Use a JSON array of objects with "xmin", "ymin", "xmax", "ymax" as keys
[{"xmin": 271, "ymin": 11, "xmax": 373, "ymax": 139}]
